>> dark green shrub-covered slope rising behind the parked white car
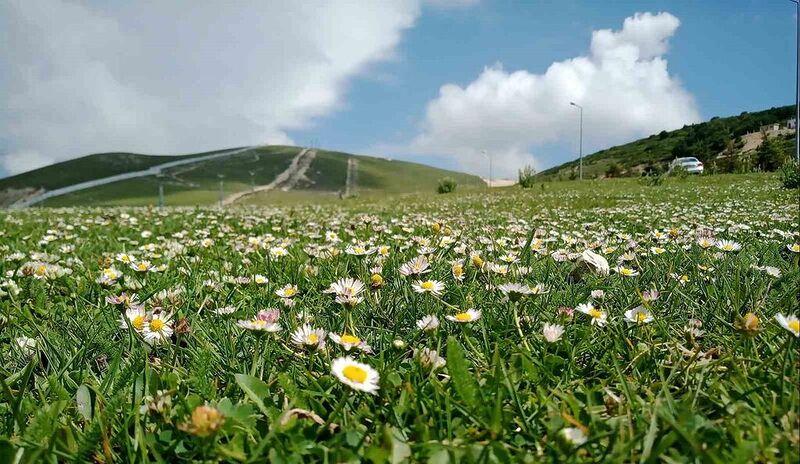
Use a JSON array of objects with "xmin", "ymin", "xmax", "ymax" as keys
[{"xmin": 538, "ymin": 105, "xmax": 795, "ymax": 180}]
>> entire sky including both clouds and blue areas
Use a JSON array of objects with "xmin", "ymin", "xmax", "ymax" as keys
[{"xmin": 0, "ymin": 0, "xmax": 795, "ymax": 176}]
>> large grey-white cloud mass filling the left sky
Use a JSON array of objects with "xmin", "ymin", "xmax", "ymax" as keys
[{"xmin": 0, "ymin": 0, "xmax": 420, "ymax": 173}]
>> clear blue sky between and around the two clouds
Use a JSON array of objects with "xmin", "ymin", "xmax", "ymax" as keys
[{"xmin": 290, "ymin": 0, "xmax": 795, "ymax": 174}]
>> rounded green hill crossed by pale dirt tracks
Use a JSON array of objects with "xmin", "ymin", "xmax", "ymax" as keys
[{"xmin": 0, "ymin": 146, "xmax": 484, "ymax": 207}]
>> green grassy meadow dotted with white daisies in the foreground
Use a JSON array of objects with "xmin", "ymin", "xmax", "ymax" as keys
[{"xmin": 0, "ymin": 176, "xmax": 800, "ymax": 463}]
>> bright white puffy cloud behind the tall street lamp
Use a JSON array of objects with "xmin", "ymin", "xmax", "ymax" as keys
[{"xmin": 410, "ymin": 13, "xmax": 700, "ymax": 175}]
